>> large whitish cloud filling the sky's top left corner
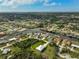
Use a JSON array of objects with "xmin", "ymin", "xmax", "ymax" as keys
[{"xmin": 0, "ymin": 0, "xmax": 37, "ymax": 6}]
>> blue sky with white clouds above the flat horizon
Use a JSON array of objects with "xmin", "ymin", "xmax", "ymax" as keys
[{"xmin": 0, "ymin": 0, "xmax": 79, "ymax": 12}]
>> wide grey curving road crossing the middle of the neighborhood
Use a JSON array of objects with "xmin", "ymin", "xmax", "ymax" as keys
[{"xmin": 0, "ymin": 28, "xmax": 78, "ymax": 43}]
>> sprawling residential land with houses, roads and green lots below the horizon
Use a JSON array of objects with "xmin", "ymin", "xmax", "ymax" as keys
[{"xmin": 0, "ymin": 13, "xmax": 79, "ymax": 59}]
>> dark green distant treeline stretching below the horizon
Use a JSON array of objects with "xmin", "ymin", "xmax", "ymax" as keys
[{"xmin": 0, "ymin": 12, "xmax": 79, "ymax": 21}]
